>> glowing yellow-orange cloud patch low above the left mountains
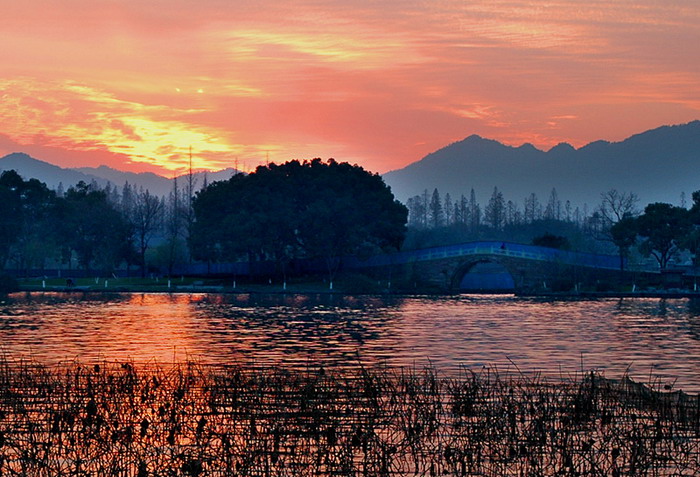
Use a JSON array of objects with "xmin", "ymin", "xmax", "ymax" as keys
[{"xmin": 0, "ymin": 79, "xmax": 242, "ymax": 170}]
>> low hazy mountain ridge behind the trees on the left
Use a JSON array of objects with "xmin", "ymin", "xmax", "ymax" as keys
[{"xmin": 0, "ymin": 153, "xmax": 241, "ymax": 196}]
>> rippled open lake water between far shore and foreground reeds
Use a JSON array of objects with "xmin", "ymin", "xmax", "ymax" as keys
[{"xmin": 0, "ymin": 293, "xmax": 700, "ymax": 392}]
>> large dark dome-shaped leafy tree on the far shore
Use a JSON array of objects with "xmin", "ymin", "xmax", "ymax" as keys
[{"xmin": 190, "ymin": 159, "xmax": 408, "ymax": 278}]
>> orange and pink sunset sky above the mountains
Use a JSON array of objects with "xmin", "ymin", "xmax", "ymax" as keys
[{"xmin": 0, "ymin": 0, "xmax": 700, "ymax": 175}]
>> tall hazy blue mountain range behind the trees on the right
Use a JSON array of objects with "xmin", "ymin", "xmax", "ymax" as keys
[{"xmin": 384, "ymin": 121, "xmax": 700, "ymax": 207}]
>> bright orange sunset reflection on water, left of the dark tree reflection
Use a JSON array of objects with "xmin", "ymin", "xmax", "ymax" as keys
[{"xmin": 4, "ymin": 293, "xmax": 216, "ymax": 363}]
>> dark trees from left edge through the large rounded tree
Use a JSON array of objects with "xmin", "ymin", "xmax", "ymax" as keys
[{"xmin": 0, "ymin": 159, "xmax": 407, "ymax": 279}]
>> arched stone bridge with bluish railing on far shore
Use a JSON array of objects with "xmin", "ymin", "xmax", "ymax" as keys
[{"xmin": 343, "ymin": 241, "xmax": 620, "ymax": 291}]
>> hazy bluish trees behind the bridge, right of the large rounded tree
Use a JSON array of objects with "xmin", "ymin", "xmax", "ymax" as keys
[{"xmin": 407, "ymin": 187, "xmax": 700, "ymax": 270}]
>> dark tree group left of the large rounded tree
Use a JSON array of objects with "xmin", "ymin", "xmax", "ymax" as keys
[{"xmin": 0, "ymin": 170, "xmax": 191, "ymax": 275}]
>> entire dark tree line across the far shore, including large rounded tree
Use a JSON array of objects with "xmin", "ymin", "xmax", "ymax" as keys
[{"xmin": 0, "ymin": 159, "xmax": 700, "ymax": 277}]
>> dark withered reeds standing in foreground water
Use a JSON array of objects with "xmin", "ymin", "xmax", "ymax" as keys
[{"xmin": 0, "ymin": 357, "xmax": 700, "ymax": 477}]
